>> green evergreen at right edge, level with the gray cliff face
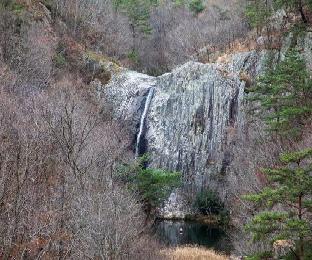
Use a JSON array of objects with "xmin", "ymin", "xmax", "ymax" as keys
[{"xmin": 249, "ymin": 49, "xmax": 312, "ymax": 137}]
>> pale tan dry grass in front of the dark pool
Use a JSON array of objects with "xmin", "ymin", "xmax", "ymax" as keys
[{"xmin": 161, "ymin": 246, "xmax": 229, "ymax": 260}]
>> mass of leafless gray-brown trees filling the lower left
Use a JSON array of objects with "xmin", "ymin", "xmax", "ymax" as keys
[{"xmin": 0, "ymin": 74, "xmax": 150, "ymax": 259}]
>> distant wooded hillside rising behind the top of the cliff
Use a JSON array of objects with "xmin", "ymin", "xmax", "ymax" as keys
[{"xmin": 50, "ymin": 0, "xmax": 247, "ymax": 74}]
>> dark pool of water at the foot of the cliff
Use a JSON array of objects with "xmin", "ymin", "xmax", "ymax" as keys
[{"xmin": 155, "ymin": 220, "xmax": 231, "ymax": 253}]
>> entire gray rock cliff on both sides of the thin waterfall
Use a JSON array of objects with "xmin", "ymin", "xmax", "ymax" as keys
[{"xmin": 102, "ymin": 51, "xmax": 264, "ymax": 217}]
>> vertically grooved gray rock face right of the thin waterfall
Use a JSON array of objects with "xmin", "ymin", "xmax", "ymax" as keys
[{"xmin": 146, "ymin": 52, "xmax": 261, "ymax": 187}]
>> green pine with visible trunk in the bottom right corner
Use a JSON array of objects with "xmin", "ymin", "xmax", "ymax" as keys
[{"xmin": 244, "ymin": 148, "xmax": 312, "ymax": 259}]
